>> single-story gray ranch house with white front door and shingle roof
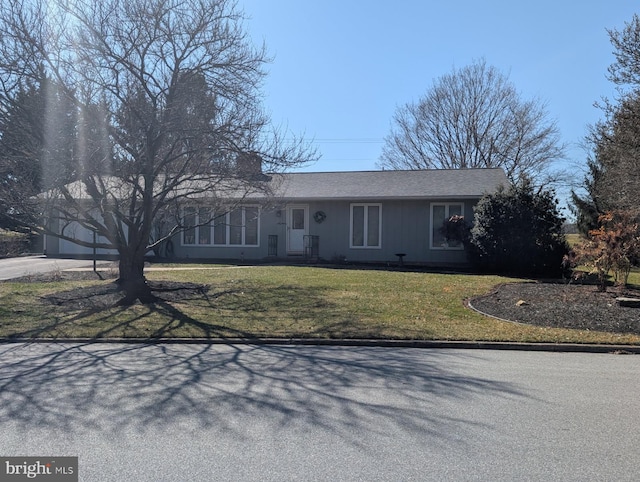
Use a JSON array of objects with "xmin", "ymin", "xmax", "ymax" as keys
[{"xmin": 45, "ymin": 169, "xmax": 508, "ymax": 266}]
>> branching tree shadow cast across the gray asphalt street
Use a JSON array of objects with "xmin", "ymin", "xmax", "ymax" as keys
[{"xmin": 0, "ymin": 343, "xmax": 525, "ymax": 448}]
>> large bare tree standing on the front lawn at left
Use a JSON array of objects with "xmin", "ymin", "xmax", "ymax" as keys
[{"xmin": 0, "ymin": 0, "xmax": 315, "ymax": 301}]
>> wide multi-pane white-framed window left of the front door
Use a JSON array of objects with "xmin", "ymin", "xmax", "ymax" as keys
[{"xmin": 182, "ymin": 206, "xmax": 260, "ymax": 246}]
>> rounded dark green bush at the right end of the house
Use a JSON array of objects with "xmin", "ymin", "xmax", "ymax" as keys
[{"xmin": 467, "ymin": 181, "xmax": 569, "ymax": 277}]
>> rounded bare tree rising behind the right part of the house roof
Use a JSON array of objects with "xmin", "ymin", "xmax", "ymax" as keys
[{"xmin": 379, "ymin": 60, "xmax": 565, "ymax": 185}]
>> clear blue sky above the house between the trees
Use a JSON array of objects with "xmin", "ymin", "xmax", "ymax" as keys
[{"xmin": 238, "ymin": 0, "xmax": 640, "ymax": 191}]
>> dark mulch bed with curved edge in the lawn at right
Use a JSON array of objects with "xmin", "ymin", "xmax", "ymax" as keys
[{"xmin": 470, "ymin": 282, "xmax": 640, "ymax": 335}]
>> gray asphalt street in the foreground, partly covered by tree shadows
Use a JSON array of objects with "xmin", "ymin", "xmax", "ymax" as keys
[{"xmin": 0, "ymin": 344, "xmax": 640, "ymax": 482}]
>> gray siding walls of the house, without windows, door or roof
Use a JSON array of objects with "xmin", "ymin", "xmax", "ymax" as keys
[{"xmin": 47, "ymin": 199, "xmax": 477, "ymax": 266}]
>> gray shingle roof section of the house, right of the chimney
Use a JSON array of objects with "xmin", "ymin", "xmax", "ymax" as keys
[{"xmin": 273, "ymin": 169, "xmax": 509, "ymax": 200}]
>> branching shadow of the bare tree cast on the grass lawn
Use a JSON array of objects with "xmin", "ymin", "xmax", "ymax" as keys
[{"xmin": 22, "ymin": 284, "xmax": 370, "ymax": 341}]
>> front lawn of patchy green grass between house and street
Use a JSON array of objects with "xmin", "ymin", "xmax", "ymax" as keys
[{"xmin": 0, "ymin": 266, "xmax": 640, "ymax": 344}]
